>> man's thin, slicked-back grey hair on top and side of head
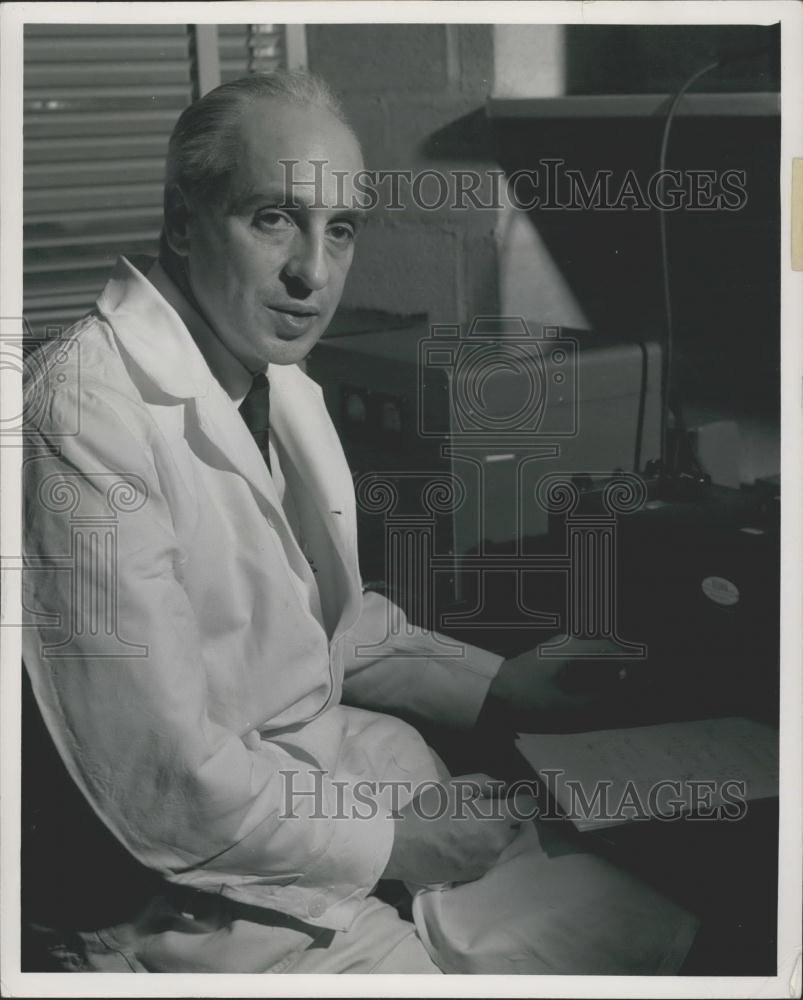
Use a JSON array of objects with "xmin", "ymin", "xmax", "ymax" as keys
[{"xmin": 165, "ymin": 70, "xmax": 353, "ymax": 208}]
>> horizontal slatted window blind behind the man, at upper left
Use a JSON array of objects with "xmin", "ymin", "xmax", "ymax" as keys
[{"xmin": 23, "ymin": 24, "xmax": 294, "ymax": 332}]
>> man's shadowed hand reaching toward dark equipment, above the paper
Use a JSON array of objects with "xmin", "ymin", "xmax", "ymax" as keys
[{"xmin": 488, "ymin": 639, "xmax": 626, "ymax": 713}]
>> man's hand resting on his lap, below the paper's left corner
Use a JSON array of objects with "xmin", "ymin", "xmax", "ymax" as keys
[{"xmin": 382, "ymin": 774, "xmax": 526, "ymax": 885}]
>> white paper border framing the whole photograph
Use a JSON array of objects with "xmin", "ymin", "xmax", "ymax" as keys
[{"xmin": 0, "ymin": 0, "xmax": 803, "ymax": 997}]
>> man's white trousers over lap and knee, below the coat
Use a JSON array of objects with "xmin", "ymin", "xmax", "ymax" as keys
[{"xmin": 44, "ymin": 822, "xmax": 697, "ymax": 975}]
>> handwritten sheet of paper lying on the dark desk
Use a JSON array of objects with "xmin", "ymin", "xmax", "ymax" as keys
[{"xmin": 516, "ymin": 718, "xmax": 778, "ymax": 830}]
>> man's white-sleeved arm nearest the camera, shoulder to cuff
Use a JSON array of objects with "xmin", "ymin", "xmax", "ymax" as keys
[{"xmin": 23, "ymin": 380, "xmax": 394, "ymax": 928}]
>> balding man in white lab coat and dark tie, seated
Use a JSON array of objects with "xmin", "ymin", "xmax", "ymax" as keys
[{"xmin": 23, "ymin": 74, "xmax": 696, "ymax": 972}]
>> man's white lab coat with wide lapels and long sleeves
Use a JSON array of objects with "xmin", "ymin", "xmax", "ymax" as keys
[{"xmin": 23, "ymin": 258, "xmax": 501, "ymax": 929}]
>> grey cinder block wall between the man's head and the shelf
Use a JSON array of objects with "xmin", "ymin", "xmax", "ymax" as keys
[{"xmin": 307, "ymin": 24, "xmax": 499, "ymax": 323}]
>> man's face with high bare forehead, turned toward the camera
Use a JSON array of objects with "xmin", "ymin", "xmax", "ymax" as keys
[{"xmin": 182, "ymin": 98, "xmax": 363, "ymax": 372}]
